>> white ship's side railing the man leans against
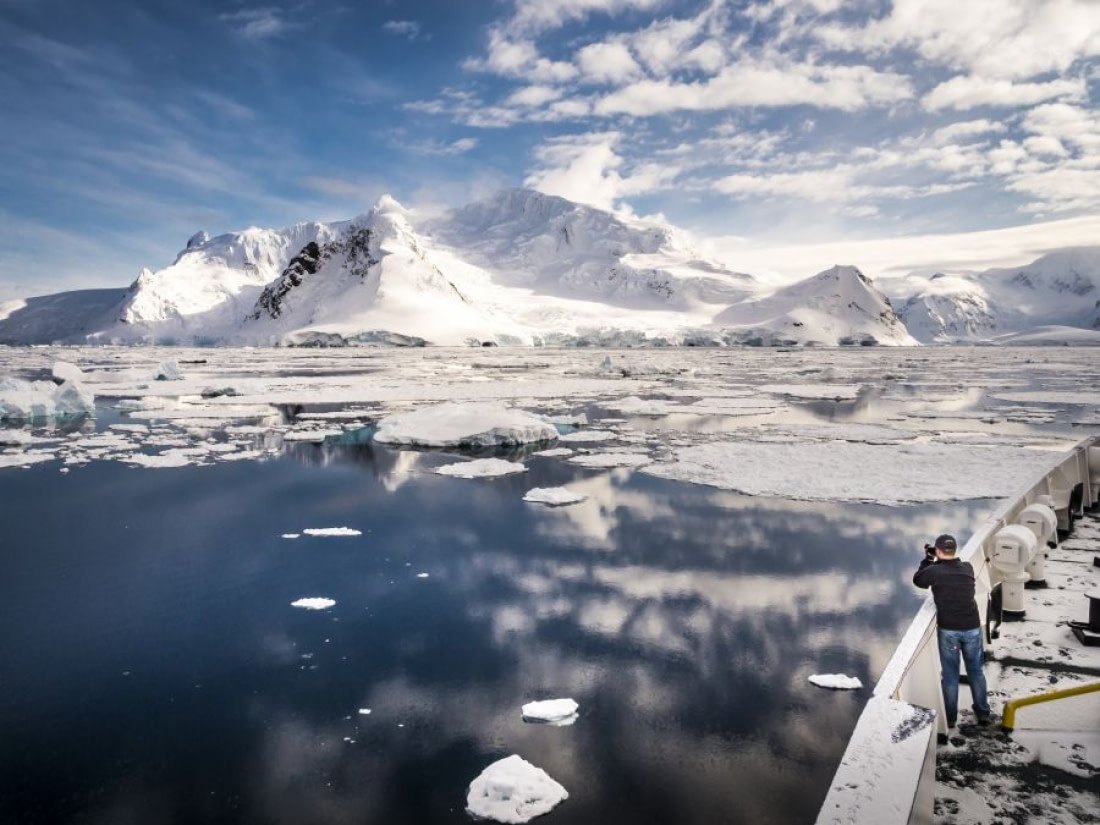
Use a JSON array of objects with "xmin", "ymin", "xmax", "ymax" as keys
[{"xmin": 817, "ymin": 437, "xmax": 1100, "ymax": 825}]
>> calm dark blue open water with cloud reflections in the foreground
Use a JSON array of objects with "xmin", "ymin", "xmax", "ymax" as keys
[{"xmin": 0, "ymin": 433, "xmax": 992, "ymax": 825}]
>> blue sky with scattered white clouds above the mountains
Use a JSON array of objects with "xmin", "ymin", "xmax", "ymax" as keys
[{"xmin": 0, "ymin": 0, "xmax": 1100, "ymax": 300}]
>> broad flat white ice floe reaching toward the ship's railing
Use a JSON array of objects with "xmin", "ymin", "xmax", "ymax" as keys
[{"xmin": 642, "ymin": 441, "xmax": 1054, "ymax": 504}]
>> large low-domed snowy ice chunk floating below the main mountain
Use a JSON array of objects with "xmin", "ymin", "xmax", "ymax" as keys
[{"xmin": 374, "ymin": 403, "xmax": 558, "ymax": 447}]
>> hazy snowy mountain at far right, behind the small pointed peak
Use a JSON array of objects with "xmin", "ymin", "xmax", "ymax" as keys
[{"xmin": 898, "ymin": 246, "xmax": 1100, "ymax": 342}]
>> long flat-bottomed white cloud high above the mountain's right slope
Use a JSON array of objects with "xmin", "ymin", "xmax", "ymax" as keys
[{"xmin": 596, "ymin": 61, "xmax": 913, "ymax": 116}]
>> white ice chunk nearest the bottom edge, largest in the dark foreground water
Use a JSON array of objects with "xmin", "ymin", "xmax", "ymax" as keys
[{"xmin": 466, "ymin": 754, "xmax": 569, "ymax": 823}]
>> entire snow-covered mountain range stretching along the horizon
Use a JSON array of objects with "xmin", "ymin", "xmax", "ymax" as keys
[{"xmin": 0, "ymin": 189, "xmax": 1100, "ymax": 345}]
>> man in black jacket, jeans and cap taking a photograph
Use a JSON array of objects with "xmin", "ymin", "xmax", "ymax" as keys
[{"xmin": 913, "ymin": 535, "xmax": 992, "ymax": 728}]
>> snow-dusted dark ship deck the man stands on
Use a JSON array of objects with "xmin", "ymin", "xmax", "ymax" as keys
[{"xmin": 934, "ymin": 512, "xmax": 1100, "ymax": 825}]
